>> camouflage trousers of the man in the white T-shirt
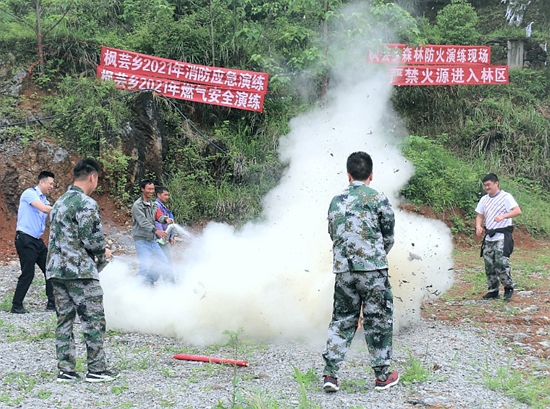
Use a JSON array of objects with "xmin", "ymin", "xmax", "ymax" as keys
[{"xmin": 483, "ymin": 240, "xmax": 514, "ymax": 292}]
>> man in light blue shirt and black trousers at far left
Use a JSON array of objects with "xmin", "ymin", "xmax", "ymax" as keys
[{"xmin": 11, "ymin": 171, "xmax": 55, "ymax": 314}]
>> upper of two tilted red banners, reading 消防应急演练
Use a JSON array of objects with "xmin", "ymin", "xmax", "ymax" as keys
[{"xmin": 101, "ymin": 47, "xmax": 269, "ymax": 94}]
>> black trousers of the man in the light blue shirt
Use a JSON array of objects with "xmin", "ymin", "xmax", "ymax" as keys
[{"xmin": 12, "ymin": 232, "xmax": 55, "ymax": 308}]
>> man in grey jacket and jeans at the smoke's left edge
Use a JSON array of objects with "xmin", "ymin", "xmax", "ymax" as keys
[{"xmin": 132, "ymin": 179, "xmax": 174, "ymax": 285}]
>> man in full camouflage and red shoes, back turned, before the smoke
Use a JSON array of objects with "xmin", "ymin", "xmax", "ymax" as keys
[{"xmin": 323, "ymin": 152, "xmax": 399, "ymax": 392}]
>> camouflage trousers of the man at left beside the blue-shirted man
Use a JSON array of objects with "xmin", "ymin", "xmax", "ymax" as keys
[{"xmin": 50, "ymin": 279, "xmax": 106, "ymax": 372}]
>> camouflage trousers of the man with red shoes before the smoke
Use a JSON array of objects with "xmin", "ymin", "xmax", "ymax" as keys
[{"xmin": 323, "ymin": 270, "xmax": 393, "ymax": 378}]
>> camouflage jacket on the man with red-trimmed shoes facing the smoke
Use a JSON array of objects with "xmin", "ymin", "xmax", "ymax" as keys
[{"xmin": 328, "ymin": 181, "xmax": 395, "ymax": 273}]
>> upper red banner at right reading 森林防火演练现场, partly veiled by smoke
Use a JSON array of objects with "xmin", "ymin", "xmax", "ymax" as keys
[{"xmin": 368, "ymin": 44, "xmax": 491, "ymax": 65}]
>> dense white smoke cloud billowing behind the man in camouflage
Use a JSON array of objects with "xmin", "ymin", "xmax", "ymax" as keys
[{"xmin": 101, "ymin": 3, "xmax": 452, "ymax": 344}]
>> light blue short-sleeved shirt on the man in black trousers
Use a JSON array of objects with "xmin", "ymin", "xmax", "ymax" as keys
[{"xmin": 16, "ymin": 186, "xmax": 50, "ymax": 239}]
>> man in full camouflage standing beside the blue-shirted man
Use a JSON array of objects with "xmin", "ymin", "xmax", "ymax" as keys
[{"xmin": 46, "ymin": 159, "xmax": 116, "ymax": 382}]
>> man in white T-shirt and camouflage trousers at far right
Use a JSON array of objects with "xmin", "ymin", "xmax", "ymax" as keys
[{"xmin": 476, "ymin": 173, "xmax": 521, "ymax": 301}]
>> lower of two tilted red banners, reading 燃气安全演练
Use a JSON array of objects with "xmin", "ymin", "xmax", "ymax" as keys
[{"xmin": 97, "ymin": 65, "xmax": 265, "ymax": 112}]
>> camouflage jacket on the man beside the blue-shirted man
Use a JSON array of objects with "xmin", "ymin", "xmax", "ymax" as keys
[{"xmin": 46, "ymin": 186, "xmax": 106, "ymax": 280}]
